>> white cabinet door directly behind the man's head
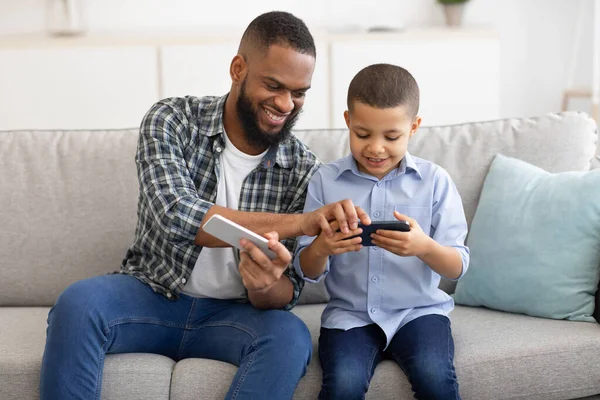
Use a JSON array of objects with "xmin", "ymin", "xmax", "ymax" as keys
[{"xmin": 160, "ymin": 41, "xmax": 329, "ymax": 129}]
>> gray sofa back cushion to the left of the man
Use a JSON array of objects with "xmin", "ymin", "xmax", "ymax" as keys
[{"xmin": 0, "ymin": 129, "xmax": 138, "ymax": 306}]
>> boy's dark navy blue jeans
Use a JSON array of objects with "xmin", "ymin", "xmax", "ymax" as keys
[{"xmin": 319, "ymin": 315, "xmax": 460, "ymax": 400}]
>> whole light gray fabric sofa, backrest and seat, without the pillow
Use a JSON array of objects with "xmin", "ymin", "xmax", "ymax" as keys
[{"xmin": 0, "ymin": 113, "xmax": 600, "ymax": 400}]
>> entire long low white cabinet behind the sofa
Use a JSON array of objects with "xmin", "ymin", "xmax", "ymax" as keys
[{"xmin": 0, "ymin": 29, "xmax": 500, "ymax": 130}]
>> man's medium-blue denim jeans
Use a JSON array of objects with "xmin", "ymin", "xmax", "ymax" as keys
[{"xmin": 40, "ymin": 275, "xmax": 312, "ymax": 400}]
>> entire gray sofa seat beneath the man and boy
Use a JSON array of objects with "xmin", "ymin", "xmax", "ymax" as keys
[{"xmin": 0, "ymin": 305, "xmax": 600, "ymax": 400}]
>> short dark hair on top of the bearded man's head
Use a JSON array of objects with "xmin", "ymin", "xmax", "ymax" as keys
[{"xmin": 238, "ymin": 11, "xmax": 317, "ymax": 57}]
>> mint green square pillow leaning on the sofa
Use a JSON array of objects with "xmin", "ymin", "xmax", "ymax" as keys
[{"xmin": 453, "ymin": 155, "xmax": 600, "ymax": 322}]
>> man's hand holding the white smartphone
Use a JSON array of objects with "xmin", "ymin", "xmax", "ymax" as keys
[{"xmin": 239, "ymin": 232, "xmax": 292, "ymax": 292}]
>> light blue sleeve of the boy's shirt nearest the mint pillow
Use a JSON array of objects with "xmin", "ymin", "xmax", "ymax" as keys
[{"xmin": 431, "ymin": 168, "xmax": 469, "ymax": 280}]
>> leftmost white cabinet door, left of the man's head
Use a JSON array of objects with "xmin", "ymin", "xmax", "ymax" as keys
[{"xmin": 0, "ymin": 46, "xmax": 158, "ymax": 130}]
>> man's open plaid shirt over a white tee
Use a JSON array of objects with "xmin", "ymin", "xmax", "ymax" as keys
[{"xmin": 120, "ymin": 96, "xmax": 320, "ymax": 309}]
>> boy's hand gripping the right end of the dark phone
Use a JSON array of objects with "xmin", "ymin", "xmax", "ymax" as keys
[{"xmin": 371, "ymin": 211, "xmax": 432, "ymax": 257}]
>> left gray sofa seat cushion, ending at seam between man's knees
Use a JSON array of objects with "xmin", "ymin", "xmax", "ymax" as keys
[{"xmin": 0, "ymin": 307, "xmax": 175, "ymax": 400}]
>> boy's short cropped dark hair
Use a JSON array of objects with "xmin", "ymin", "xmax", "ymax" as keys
[{"xmin": 348, "ymin": 64, "xmax": 419, "ymax": 117}]
